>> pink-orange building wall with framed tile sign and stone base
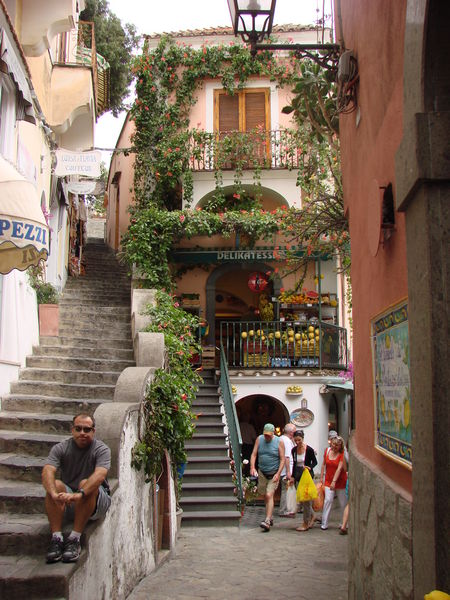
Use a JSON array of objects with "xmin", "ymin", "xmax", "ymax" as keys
[{"xmin": 336, "ymin": 0, "xmax": 450, "ymax": 600}]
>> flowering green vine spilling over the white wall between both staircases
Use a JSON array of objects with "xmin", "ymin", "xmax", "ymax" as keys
[{"xmin": 132, "ymin": 291, "xmax": 201, "ymax": 481}]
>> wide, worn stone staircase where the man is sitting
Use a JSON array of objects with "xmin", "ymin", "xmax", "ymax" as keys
[{"xmin": 0, "ymin": 239, "xmax": 134, "ymax": 599}]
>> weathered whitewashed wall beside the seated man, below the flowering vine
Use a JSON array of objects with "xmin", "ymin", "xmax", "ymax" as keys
[{"xmin": 69, "ymin": 405, "xmax": 176, "ymax": 600}]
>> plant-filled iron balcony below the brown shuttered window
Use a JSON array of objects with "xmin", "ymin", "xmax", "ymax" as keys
[{"xmin": 190, "ymin": 129, "xmax": 302, "ymax": 172}]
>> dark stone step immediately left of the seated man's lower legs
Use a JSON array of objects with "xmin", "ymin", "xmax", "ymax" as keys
[{"xmin": 0, "ymin": 513, "xmax": 50, "ymax": 563}]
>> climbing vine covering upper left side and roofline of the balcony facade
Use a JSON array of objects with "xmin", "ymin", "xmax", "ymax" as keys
[{"xmin": 132, "ymin": 36, "xmax": 298, "ymax": 210}]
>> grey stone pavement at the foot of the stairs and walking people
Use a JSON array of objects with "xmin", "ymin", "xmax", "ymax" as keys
[{"xmin": 128, "ymin": 507, "xmax": 348, "ymax": 600}]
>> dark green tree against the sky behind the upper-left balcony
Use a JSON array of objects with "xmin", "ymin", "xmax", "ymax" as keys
[{"xmin": 80, "ymin": 0, "xmax": 140, "ymax": 116}]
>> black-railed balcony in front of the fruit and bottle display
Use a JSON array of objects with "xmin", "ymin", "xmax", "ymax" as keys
[{"xmin": 220, "ymin": 321, "xmax": 348, "ymax": 370}]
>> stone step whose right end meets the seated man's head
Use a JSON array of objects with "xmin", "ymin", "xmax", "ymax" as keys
[{"xmin": 0, "ymin": 410, "xmax": 72, "ymax": 435}]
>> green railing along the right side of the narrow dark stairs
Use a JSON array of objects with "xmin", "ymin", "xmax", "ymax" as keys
[{"xmin": 220, "ymin": 345, "xmax": 244, "ymax": 507}]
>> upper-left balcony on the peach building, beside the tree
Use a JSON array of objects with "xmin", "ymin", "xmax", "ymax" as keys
[{"xmin": 54, "ymin": 21, "xmax": 110, "ymax": 116}]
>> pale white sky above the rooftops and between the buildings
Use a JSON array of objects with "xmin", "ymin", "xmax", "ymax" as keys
[{"xmin": 95, "ymin": 0, "xmax": 331, "ymax": 164}]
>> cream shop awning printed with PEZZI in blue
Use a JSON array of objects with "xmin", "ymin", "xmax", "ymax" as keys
[{"xmin": 0, "ymin": 156, "xmax": 48, "ymax": 275}]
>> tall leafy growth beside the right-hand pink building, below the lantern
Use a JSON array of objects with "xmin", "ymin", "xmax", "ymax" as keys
[{"xmin": 283, "ymin": 61, "xmax": 350, "ymax": 271}]
